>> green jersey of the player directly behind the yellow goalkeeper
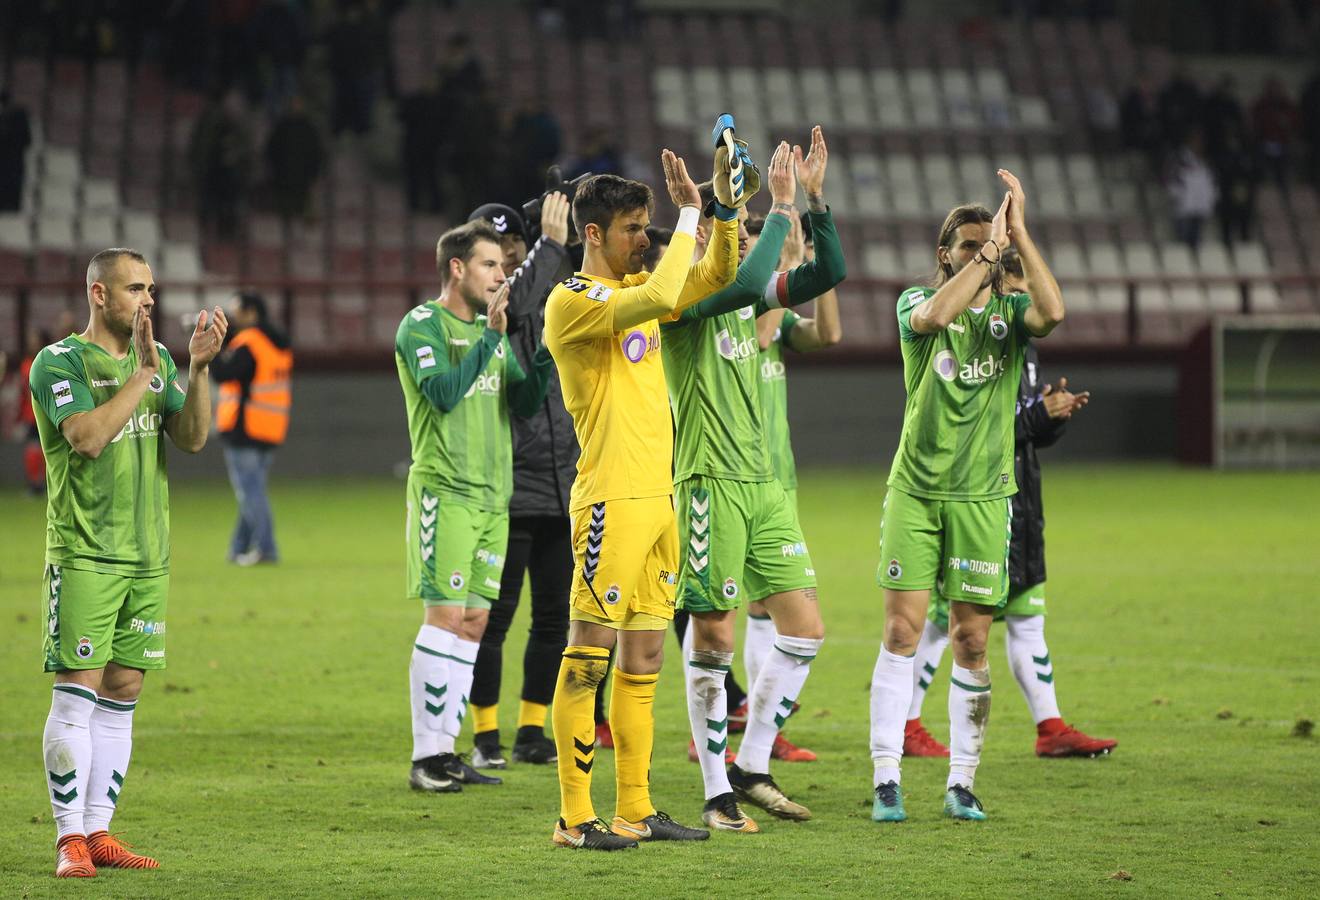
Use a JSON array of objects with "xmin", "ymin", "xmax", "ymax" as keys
[{"xmin": 661, "ymin": 302, "xmax": 775, "ymax": 483}]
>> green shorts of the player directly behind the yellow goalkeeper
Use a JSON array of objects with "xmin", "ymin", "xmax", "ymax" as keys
[{"xmin": 675, "ymin": 475, "xmax": 816, "ymax": 612}]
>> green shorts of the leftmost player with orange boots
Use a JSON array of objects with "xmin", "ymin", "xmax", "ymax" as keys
[{"xmin": 41, "ymin": 565, "xmax": 169, "ymax": 672}]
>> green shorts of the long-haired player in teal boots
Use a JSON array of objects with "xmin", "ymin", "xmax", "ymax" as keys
[{"xmin": 876, "ymin": 487, "xmax": 1012, "ymax": 606}]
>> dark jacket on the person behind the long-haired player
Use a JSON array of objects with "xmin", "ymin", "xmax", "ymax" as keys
[{"xmin": 1008, "ymin": 344, "xmax": 1067, "ymax": 590}]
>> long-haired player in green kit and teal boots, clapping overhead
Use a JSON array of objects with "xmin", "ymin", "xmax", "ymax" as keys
[{"xmin": 871, "ymin": 169, "xmax": 1064, "ymax": 822}]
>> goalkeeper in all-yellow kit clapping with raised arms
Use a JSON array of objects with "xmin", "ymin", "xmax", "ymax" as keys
[{"xmin": 545, "ymin": 136, "xmax": 754, "ymax": 850}]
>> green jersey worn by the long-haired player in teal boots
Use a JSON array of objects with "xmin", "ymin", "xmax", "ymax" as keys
[{"xmin": 890, "ymin": 288, "xmax": 1031, "ymax": 500}]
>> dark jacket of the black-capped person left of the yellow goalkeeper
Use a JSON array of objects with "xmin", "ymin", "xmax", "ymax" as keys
[{"xmin": 508, "ymin": 230, "xmax": 578, "ymax": 516}]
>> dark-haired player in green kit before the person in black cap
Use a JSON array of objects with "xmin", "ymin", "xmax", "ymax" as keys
[{"xmin": 395, "ymin": 220, "xmax": 554, "ymax": 793}]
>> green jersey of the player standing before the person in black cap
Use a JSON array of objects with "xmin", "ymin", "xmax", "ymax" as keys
[{"xmin": 395, "ymin": 301, "xmax": 525, "ymax": 511}]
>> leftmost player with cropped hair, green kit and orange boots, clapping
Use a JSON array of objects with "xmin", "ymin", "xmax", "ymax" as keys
[{"xmin": 30, "ymin": 248, "xmax": 228, "ymax": 878}]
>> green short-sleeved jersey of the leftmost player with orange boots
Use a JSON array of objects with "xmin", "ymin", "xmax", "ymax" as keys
[{"xmin": 29, "ymin": 334, "xmax": 186, "ymax": 577}]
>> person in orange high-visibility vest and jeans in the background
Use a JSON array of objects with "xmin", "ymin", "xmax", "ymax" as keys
[{"xmin": 211, "ymin": 292, "xmax": 293, "ymax": 566}]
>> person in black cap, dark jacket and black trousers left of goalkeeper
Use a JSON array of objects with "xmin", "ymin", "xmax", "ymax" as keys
[{"xmin": 469, "ymin": 195, "xmax": 578, "ymax": 768}]
